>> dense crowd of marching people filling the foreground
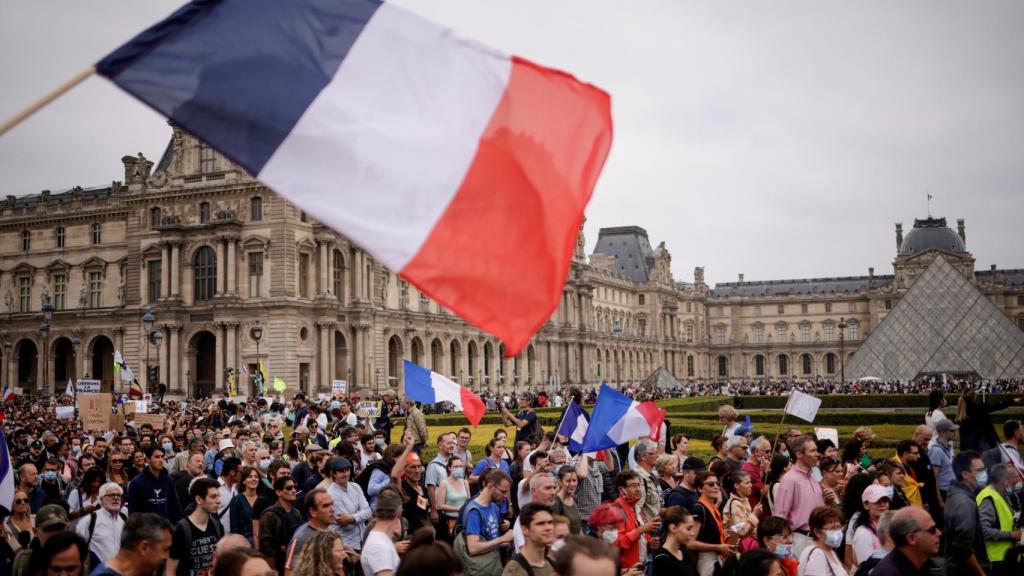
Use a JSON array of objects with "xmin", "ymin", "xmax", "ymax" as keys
[{"xmin": 6, "ymin": 386, "xmax": 1024, "ymax": 576}]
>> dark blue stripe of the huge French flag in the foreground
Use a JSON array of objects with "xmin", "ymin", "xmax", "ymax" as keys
[{"xmin": 96, "ymin": 0, "xmax": 381, "ymax": 174}]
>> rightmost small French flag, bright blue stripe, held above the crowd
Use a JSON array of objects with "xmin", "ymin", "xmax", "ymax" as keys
[{"xmin": 582, "ymin": 383, "xmax": 665, "ymax": 452}]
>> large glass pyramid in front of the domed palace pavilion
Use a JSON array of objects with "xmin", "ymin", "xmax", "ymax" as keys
[{"xmin": 846, "ymin": 256, "xmax": 1024, "ymax": 381}]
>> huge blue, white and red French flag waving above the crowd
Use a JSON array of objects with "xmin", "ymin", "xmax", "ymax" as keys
[{"xmin": 96, "ymin": 0, "xmax": 611, "ymax": 356}]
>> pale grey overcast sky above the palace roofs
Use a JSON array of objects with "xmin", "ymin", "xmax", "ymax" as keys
[{"xmin": 0, "ymin": 0, "xmax": 1024, "ymax": 283}]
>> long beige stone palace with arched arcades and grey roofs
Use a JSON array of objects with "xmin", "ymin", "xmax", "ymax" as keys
[{"xmin": 6, "ymin": 127, "xmax": 1024, "ymax": 397}]
